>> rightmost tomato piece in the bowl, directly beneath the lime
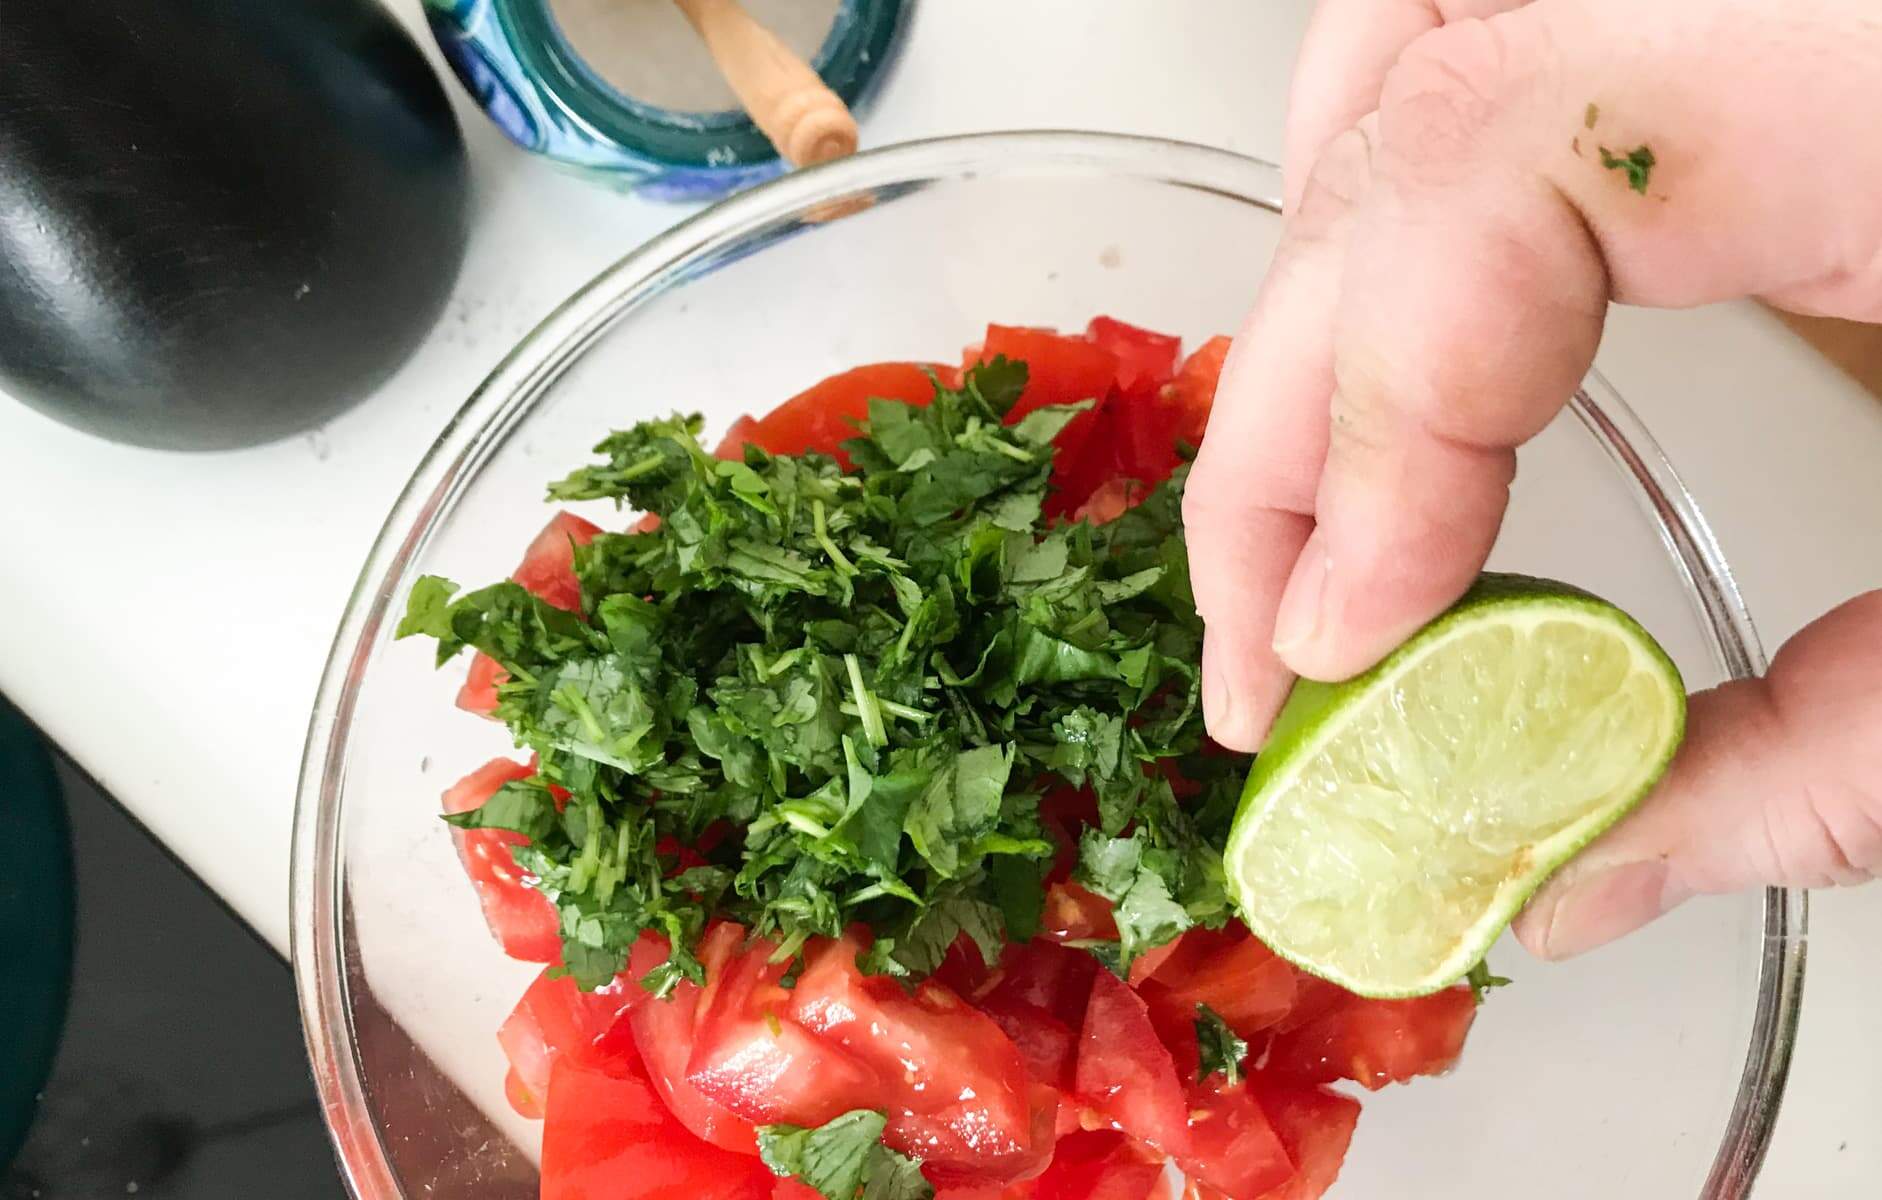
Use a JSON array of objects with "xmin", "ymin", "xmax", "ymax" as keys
[{"xmin": 1265, "ymin": 987, "xmax": 1477, "ymax": 1091}]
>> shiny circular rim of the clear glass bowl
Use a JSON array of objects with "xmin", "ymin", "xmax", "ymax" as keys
[{"xmin": 288, "ymin": 130, "xmax": 1809, "ymax": 1200}]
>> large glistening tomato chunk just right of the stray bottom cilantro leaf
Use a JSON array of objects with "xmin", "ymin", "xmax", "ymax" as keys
[{"xmin": 790, "ymin": 939, "xmax": 1056, "ymax": 1185}]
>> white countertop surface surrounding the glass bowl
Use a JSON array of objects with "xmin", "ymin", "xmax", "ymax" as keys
[{"xmin": 0, "ymin": 0, "xmax": 1882, "ymax": 1200}]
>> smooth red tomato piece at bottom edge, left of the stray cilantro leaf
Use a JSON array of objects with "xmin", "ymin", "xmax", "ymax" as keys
[{"xmin": 542, "ymin": 1048, "xmax": 777, "ymax": 1200}]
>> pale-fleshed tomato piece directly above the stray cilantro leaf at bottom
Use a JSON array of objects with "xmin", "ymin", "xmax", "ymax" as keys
[{"xmin": 687, "ymin": 922, "xmax": 881, "ymax": 1125}]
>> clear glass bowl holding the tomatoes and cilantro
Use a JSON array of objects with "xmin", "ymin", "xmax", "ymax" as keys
[{"xmin": 292, "ymin": 134, "xmax": 1803, "ymax": 1200}]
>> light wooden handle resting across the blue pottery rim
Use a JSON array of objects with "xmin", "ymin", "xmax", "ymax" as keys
[{"xmin": 674, "ymin": 0, "xmax": 856, "ymax": 167}]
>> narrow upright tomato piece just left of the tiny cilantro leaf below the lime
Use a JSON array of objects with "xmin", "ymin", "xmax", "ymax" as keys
[{"xmin": 1073, "ymin": 971, "xmax": 1189, "ymax": 1155}]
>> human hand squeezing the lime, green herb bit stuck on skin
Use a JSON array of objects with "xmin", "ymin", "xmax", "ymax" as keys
[{"xmin": 1184, "ymin": 0, "xmax": 1882, "ymax": 957}]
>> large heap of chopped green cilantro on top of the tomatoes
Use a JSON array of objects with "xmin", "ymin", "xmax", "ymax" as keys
[{"xmin": 399, "ymin": 359, "xmax": 1246, "ymax": 993}]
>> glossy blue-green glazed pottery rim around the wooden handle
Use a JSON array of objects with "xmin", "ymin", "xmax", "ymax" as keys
[{"xmin": 423, "ymin": 0, "xmax": 915, "ymax": 201}]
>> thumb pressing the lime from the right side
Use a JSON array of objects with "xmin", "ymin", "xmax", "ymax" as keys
[{"xmin": 1515, "ymin": 591, "xmax": 1882, "ymax": 959}]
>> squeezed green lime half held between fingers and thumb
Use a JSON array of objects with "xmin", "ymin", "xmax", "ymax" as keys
[{"xmin": 1225, "ymin": 576, "xmax": 1686, "ymax": 997}]
